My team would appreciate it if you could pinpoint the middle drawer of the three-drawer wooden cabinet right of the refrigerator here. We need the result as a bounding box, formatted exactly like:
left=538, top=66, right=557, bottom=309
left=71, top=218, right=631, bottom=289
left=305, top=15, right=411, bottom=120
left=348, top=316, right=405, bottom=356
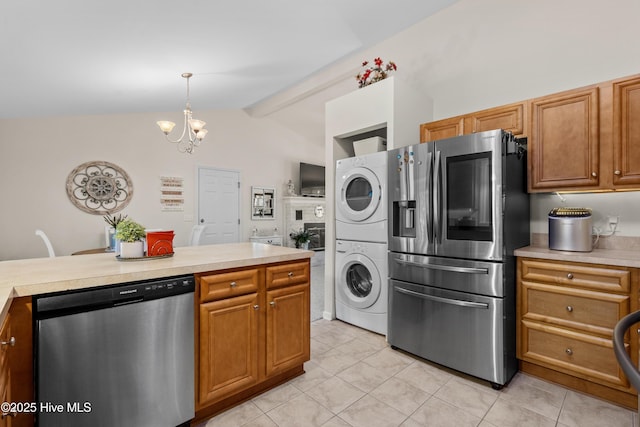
left=521, top=282, right=630, bottom=338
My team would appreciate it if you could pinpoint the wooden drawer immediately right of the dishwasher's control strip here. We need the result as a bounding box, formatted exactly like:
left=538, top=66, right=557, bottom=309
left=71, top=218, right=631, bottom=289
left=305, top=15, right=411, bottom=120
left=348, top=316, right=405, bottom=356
left=198, top=268, right=260, bottom=302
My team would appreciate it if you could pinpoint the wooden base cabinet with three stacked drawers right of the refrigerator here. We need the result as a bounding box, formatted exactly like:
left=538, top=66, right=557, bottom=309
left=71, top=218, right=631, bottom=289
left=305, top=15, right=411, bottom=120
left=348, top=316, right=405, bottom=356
left=517, top=258, right=638, bottom=407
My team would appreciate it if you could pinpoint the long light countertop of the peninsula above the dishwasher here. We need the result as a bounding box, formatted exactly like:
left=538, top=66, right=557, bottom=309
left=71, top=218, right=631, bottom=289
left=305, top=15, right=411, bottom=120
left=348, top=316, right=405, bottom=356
left=0, top=243, right=313, bottom=322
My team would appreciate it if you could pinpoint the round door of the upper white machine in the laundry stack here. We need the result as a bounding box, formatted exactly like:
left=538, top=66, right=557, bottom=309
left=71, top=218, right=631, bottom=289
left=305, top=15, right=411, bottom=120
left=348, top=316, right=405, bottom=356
left=338, top=168, right=381, bottom=222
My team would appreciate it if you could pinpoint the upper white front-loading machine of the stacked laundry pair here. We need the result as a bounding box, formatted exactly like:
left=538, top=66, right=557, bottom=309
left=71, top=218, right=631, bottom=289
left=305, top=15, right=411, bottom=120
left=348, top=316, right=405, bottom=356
left=335, top=151, right=388, bottom=242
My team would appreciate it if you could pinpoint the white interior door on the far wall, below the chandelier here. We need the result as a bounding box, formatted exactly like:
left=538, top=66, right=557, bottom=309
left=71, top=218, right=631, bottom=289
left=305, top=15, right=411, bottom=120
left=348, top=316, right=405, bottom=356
left=198, top=167, right=240, bottom=245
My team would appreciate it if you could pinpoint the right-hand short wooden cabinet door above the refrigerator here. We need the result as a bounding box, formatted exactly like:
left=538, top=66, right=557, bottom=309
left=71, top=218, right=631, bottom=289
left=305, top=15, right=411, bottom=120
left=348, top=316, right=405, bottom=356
left=464, top=102, right=525, bottom=135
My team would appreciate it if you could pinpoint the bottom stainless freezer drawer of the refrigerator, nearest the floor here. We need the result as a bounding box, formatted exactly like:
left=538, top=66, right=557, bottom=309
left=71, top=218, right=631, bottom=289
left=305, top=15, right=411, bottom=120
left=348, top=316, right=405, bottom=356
left=387, top=280, right=516, bottom=386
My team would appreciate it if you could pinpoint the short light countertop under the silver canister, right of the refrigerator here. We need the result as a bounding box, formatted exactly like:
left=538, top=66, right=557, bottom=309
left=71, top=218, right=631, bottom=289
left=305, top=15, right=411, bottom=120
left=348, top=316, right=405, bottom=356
left=514, top=246, right=640, bottom=268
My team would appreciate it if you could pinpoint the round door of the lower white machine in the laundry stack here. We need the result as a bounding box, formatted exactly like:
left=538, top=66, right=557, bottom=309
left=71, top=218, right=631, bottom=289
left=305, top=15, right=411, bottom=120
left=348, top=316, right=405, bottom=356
left=339, top=254, right=382, bottom=308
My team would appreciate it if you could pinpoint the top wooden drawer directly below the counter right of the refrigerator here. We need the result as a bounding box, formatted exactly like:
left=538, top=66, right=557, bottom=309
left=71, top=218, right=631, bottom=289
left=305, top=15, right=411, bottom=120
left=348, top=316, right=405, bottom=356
left=522, top=259, right=631, bottom=293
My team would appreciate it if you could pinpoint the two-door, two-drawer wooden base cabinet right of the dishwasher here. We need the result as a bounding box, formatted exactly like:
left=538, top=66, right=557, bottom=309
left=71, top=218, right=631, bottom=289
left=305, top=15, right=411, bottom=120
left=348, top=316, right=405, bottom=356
left=196, top=260, right=310, bottom=420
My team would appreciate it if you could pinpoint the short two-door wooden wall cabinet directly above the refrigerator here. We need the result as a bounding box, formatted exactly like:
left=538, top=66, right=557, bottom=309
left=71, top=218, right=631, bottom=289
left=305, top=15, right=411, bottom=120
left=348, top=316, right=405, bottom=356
left=420, top=102, right=527, bottom=142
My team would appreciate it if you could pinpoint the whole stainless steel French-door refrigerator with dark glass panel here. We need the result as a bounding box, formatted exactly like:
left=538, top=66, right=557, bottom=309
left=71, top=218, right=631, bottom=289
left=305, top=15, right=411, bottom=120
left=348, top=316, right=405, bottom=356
left=388, top=130, right=529, bottom=387
